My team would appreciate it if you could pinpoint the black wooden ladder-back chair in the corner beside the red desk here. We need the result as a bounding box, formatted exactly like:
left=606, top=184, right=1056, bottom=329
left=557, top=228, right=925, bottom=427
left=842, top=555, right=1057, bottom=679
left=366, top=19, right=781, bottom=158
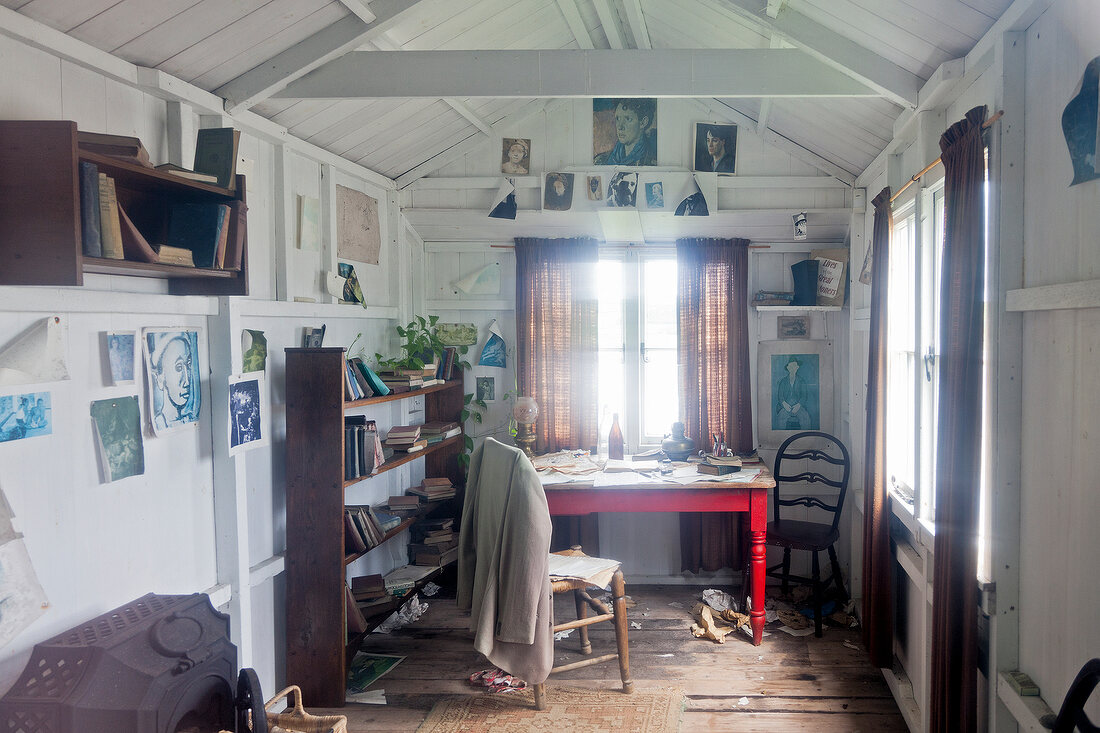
left=746, top=430, right=851, bottom=636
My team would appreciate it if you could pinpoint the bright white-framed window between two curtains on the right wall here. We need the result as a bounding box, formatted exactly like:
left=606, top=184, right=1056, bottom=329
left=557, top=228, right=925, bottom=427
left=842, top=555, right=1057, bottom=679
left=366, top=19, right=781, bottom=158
left=887, top=179, right=944, bottom=522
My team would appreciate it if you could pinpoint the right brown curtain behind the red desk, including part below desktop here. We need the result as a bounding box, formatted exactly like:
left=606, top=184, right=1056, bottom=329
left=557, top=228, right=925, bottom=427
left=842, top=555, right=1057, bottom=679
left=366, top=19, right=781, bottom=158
left=677, top=239, right=752, bottom=572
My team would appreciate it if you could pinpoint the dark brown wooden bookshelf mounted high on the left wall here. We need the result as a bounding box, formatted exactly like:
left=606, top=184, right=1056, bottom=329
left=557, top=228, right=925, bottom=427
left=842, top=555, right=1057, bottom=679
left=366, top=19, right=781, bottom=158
left=0, top=120, right=249, bottom=295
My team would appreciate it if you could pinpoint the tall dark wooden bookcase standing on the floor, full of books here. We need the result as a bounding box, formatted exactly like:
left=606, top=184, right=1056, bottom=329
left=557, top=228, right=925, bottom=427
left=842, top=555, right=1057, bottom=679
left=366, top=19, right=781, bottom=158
left=286, top=348, right=464, bottom=707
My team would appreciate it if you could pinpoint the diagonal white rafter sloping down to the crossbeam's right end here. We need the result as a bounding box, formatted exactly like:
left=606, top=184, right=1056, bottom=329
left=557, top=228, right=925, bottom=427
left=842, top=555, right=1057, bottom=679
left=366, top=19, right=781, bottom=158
left=726, top=0, right=924, bottom=107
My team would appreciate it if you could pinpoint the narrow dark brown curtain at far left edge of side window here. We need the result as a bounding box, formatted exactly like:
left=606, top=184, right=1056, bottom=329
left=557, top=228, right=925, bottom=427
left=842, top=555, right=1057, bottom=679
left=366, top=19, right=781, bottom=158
left=862, top=186, right=893, bottom=667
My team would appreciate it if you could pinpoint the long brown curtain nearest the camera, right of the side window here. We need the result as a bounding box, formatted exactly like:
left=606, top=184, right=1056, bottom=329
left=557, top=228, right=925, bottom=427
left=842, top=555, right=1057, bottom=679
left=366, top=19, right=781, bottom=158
left=931, top=102, right=986, bottom=733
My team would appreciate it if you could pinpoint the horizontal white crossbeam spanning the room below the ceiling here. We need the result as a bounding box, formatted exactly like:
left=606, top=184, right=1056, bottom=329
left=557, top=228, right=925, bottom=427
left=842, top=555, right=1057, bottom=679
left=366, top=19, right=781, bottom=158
left=274, top=48, right=878, bottom=99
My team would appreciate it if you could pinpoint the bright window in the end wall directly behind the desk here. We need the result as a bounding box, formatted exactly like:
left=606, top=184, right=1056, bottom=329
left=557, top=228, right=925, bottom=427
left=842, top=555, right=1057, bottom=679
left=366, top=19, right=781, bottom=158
left=597, top=248, right=680, bottom=450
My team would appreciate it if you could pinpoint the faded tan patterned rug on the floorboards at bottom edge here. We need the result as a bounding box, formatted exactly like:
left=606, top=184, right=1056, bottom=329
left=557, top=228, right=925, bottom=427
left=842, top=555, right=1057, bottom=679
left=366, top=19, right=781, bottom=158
left=417, top=685, right=684, bottom=733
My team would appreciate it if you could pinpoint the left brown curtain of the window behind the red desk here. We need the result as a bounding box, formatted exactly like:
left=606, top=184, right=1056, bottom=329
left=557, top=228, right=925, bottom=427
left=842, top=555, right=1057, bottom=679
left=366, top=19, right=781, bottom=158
left=516, top=239, right=600, bottom=452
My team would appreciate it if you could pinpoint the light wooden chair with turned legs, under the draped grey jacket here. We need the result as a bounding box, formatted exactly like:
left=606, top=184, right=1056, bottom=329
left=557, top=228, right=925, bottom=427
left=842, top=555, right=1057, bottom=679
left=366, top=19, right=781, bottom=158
left=535, top=545, right=634, bottom=710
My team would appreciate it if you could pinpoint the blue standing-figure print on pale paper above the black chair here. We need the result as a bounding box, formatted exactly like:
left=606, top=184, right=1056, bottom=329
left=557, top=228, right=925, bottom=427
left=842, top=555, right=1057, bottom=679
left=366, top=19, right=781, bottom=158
left=757, top=340, right=833, bottom=448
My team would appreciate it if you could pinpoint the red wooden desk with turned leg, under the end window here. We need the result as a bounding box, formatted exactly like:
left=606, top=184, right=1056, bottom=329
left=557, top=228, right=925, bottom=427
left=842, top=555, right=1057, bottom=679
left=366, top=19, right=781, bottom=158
left=543, top=468, right=776, bottom=646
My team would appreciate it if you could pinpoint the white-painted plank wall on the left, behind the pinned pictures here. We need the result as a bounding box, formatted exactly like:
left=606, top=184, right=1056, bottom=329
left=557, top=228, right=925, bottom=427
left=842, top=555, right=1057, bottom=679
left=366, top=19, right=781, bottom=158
left=0, top=22, right=404, bottom=690
